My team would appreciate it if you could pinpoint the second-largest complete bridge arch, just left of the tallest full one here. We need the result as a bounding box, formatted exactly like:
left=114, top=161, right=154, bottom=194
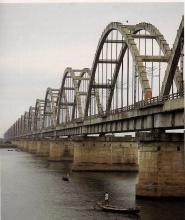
left=57, top=67, right=90, bottom=124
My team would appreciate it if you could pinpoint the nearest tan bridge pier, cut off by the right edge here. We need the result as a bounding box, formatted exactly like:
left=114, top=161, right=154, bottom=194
left=136, top=134, right=185, bottom=197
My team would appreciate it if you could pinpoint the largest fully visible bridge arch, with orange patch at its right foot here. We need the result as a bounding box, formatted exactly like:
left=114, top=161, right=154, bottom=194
left=85, top=18, right=183, bottom=116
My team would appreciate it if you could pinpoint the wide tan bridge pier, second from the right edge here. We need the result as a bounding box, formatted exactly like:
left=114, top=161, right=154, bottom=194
left=73, top=137, right=138, bottom=171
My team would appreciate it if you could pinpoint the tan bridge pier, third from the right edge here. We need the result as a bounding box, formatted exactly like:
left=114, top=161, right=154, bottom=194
left=49, top=139, right=74, bottom=161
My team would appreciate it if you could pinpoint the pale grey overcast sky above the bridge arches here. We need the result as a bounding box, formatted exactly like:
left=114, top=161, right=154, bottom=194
left=0, top=3, right=184, bottom=137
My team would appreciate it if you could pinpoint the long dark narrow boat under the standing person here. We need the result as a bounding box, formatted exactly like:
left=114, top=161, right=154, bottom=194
left=97, top=202, right=140, bottom=214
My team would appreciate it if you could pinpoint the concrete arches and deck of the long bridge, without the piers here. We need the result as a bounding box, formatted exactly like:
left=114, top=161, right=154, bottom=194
left=5, top=17, right=184, bottom=139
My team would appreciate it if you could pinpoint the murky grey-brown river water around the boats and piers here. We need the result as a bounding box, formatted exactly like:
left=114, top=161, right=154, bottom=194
left=0, top=149, right=185, bottom=220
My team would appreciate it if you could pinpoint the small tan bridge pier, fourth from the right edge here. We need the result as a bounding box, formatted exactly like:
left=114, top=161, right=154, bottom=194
left=36, top=140, right=50, bottom=157
